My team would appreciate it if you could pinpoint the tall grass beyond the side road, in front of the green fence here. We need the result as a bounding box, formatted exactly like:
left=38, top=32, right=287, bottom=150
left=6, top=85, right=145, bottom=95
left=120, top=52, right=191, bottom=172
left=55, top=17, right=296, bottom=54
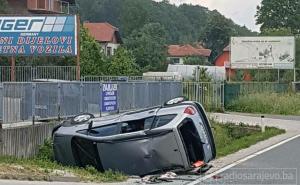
left=226, top=93, right=300, bottom=116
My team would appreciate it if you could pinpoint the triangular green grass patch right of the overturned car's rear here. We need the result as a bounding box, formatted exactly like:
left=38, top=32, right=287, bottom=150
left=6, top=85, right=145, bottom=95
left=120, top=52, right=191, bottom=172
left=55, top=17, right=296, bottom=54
left=211, top=120, right=285, bottom=157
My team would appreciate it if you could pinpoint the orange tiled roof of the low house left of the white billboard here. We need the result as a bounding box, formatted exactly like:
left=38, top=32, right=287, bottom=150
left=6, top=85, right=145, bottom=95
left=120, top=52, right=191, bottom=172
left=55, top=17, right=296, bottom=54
left=168, top=44, right=211, bottom=57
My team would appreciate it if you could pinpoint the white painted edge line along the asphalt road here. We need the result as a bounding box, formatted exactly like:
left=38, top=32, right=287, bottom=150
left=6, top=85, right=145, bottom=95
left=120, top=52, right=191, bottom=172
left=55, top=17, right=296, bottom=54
left=187, top=134, right=300, bottom=185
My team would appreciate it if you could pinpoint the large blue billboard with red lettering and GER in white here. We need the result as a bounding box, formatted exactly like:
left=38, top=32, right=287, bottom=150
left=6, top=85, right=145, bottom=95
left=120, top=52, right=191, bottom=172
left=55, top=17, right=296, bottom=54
left=0, top=15, right=77, bottom=56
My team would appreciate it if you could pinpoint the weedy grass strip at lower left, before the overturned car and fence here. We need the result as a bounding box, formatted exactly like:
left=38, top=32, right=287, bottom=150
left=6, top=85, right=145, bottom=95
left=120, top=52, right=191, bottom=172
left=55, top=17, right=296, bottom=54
left=0, top=140, right=128, bottom=182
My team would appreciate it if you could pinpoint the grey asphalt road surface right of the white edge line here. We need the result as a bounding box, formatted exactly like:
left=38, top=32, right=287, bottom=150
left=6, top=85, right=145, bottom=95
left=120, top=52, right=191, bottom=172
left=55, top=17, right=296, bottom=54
left=199, top=138, right=300, bottom=185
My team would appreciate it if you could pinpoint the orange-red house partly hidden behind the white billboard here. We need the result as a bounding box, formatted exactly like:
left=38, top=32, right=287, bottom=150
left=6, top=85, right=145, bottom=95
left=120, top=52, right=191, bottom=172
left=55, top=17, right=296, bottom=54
left=214, top=45, right=252, bottom=81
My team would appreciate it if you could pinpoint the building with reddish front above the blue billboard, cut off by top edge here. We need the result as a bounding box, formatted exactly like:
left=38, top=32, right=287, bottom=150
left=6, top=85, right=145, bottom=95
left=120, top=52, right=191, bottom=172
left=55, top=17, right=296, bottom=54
left=7, top=0, right=75, bottom=15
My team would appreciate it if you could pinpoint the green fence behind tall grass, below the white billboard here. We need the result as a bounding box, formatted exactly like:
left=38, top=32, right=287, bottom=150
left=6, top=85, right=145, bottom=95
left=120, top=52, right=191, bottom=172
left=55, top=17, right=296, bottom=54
left=224, top=82, right=291, bottom=107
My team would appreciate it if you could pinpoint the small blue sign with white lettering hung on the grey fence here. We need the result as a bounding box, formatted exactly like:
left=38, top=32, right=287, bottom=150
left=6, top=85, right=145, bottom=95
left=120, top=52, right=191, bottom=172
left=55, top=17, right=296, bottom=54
left=101, top=83, right=118, bottom=112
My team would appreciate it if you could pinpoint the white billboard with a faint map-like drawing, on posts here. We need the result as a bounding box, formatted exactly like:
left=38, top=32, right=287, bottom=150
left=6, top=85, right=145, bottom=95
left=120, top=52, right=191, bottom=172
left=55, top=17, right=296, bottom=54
left=231, top=37, right=295, bottom=69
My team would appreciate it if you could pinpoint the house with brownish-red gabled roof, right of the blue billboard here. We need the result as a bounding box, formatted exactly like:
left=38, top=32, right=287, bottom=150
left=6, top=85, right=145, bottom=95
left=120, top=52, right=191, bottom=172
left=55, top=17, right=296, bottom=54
left=83, top=22, right=122, bottom=56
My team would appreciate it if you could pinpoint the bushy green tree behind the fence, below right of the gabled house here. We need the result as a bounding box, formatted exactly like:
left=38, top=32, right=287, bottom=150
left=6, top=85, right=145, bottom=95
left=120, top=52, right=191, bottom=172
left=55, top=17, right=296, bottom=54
left=106, top=47, right=140, bottom=76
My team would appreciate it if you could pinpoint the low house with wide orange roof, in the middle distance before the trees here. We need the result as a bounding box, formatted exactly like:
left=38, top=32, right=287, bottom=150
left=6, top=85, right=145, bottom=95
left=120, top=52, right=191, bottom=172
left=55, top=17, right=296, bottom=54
left=168, top=44, right=211, bottom=64
